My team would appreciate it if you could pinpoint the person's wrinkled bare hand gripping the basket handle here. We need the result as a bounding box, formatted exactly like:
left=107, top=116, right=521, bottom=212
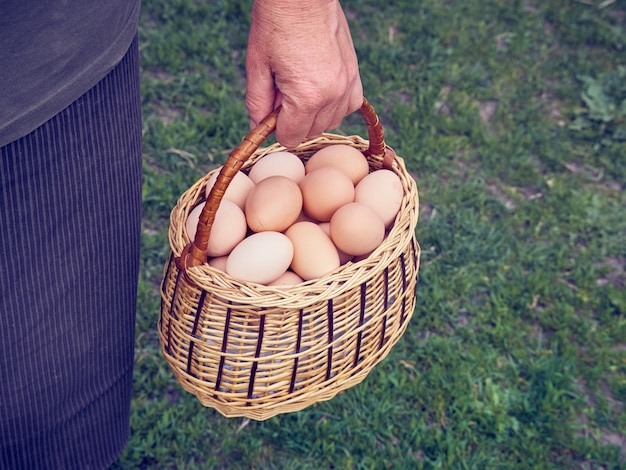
left=246, top=0, right=363, bottom=148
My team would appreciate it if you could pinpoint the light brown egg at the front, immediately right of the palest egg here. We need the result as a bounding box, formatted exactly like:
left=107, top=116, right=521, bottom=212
left=285, top=222, right=339, bottom=280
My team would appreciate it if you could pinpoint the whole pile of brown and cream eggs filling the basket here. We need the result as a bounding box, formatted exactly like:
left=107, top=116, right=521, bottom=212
left=185, top=144, right=404, bottom=286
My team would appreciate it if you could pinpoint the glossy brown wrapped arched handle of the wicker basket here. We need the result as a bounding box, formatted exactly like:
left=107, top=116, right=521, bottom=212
left=176, top=98, right=396, bottom=272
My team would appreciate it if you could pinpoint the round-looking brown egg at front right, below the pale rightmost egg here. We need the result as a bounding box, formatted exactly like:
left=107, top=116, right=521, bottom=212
left=330, top=202, right=385, bottom=256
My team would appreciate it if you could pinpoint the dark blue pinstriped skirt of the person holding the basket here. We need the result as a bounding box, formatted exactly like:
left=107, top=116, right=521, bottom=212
left=0, top=35, right=141, bottom=470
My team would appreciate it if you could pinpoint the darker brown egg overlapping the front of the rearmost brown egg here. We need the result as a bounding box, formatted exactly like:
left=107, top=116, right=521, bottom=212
left=300, top=166, right=354, bottom=222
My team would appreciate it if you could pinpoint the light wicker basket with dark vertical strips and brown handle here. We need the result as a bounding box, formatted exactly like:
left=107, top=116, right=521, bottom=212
left=158, top=100, right=420, bottom=420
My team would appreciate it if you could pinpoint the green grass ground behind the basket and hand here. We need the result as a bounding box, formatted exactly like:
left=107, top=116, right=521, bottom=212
left=113, top=0, right=626, bottom=469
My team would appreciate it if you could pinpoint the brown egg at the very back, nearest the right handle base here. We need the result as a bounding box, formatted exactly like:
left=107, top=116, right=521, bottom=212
left=305, top=144, right=369, bottom=184
